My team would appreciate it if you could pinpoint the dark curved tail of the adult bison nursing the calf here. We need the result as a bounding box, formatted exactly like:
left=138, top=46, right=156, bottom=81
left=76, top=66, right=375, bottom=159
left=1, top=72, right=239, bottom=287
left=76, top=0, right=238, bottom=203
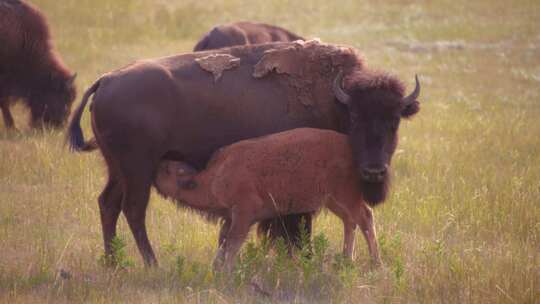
left=66, top=80, right=99, bottom=152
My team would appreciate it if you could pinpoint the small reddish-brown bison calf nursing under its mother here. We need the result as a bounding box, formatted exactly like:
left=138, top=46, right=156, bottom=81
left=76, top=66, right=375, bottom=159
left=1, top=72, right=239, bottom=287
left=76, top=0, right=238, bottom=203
left=155, top=128, right=379, bottom=270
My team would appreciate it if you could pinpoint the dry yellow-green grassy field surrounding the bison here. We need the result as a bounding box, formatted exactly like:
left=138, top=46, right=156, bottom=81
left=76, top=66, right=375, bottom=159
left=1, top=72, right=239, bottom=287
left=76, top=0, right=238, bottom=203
left=0, top=0, right=540, bottom=304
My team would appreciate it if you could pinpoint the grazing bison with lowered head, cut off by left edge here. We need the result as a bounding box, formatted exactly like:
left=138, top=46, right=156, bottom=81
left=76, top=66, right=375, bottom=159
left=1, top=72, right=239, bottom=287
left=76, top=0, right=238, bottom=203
left=0, top=0, right=75, bottom=128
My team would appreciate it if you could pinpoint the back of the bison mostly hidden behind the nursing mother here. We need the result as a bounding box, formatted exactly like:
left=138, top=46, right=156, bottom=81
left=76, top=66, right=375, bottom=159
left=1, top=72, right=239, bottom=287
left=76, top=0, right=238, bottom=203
left=193, top=21, right=304, bottom=52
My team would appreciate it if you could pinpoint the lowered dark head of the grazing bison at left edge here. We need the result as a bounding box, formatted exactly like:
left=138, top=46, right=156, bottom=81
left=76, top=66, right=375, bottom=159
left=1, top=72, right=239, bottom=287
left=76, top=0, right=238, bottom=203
left=32, top=74, right=77, bottom=127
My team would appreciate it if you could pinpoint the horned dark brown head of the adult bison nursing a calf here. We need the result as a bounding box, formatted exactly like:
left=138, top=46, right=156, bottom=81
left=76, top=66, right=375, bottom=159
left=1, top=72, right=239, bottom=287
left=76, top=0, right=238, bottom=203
left=333, top=71, right=420, bottom=205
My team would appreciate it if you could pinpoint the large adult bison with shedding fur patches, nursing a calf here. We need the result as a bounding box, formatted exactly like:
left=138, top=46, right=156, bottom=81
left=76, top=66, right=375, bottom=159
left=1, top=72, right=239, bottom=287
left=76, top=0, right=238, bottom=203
left=68, top=41, right=420, bottom=264
